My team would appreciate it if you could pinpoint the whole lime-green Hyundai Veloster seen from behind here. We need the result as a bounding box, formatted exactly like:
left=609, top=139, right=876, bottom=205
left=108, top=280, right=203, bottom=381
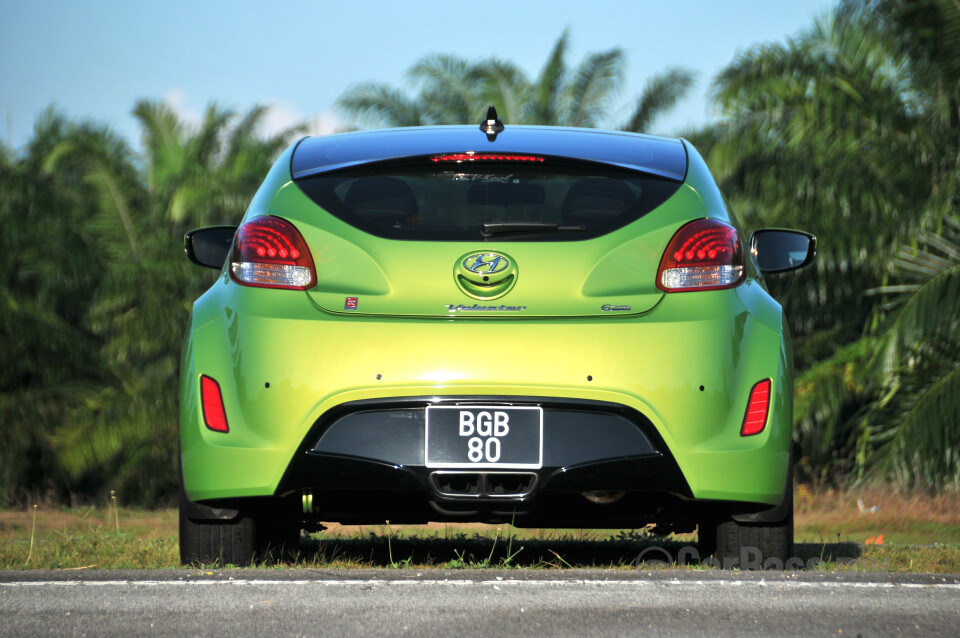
left=180, top=108, right=816, bottom=567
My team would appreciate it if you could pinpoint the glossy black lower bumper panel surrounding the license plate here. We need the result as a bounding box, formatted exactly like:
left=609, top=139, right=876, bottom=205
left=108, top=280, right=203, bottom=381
left=276, top=396, right=692, bottom=520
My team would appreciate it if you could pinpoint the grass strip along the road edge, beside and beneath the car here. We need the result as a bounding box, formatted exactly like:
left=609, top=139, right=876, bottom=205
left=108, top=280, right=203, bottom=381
left=0, top=486, right=960, bottom=573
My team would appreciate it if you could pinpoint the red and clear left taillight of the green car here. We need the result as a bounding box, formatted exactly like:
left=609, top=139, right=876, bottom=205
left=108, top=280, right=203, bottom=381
left=230, top=215, right=317, bottom=290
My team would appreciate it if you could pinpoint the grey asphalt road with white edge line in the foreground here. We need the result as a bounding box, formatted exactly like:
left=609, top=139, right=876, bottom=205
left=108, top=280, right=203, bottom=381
left=0, top=569, right=960, bottom=638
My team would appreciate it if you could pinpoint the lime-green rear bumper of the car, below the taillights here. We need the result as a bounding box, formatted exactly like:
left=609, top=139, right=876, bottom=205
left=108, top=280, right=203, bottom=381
left=181, top=283, right=792, bottom=520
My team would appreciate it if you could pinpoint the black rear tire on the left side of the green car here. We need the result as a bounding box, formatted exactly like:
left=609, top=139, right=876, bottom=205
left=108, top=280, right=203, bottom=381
left=180, top=502, right=257, bottom=565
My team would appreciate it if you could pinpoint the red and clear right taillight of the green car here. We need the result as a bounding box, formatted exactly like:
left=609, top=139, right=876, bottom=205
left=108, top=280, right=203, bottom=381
left=657, top=219, right=747, bottom=292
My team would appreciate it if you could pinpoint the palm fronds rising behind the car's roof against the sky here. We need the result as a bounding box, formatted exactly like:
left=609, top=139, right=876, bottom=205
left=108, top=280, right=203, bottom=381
left=337, top=31, right=694, bottom=132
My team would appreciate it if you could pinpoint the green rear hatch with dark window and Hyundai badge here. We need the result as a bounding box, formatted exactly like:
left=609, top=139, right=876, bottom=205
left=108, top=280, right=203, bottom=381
left=272, top=131, right=703, bottom=317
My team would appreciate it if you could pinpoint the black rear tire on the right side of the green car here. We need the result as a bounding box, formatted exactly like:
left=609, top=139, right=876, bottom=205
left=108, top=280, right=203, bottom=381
left=698, top=503, right=793, bottom=569
